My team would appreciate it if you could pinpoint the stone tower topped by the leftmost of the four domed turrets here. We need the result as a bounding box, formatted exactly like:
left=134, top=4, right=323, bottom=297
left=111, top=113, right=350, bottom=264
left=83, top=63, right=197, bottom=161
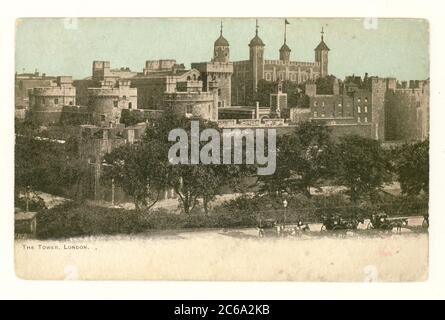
left=192, top=23, right=233, bottom=108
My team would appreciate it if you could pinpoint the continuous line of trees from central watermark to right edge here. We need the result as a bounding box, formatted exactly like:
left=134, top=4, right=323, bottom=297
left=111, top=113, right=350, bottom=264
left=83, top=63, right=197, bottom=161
left=101, top=114, right=429, bottom=213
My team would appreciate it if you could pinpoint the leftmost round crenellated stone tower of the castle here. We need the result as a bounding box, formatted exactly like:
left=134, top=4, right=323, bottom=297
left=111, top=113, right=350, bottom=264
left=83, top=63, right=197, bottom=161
left=29, top=77, right=76, bottom=124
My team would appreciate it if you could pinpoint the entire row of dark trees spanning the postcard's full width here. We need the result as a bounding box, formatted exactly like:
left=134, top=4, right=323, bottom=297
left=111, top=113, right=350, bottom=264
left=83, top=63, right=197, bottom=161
left=15, top=114, right=429, bottom=213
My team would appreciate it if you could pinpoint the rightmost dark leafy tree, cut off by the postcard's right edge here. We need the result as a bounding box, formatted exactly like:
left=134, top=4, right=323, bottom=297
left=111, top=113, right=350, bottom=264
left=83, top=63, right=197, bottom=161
left=394, top=140, right=429, bottom=196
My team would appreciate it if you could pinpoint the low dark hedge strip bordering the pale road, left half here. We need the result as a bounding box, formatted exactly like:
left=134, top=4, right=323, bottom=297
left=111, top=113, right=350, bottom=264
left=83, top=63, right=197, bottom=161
left=37, top=202, right=256, bottom=239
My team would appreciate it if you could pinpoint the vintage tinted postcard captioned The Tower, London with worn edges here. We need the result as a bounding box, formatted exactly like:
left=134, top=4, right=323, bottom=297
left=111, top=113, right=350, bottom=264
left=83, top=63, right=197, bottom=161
left=14, top=17, right=430, bottom=282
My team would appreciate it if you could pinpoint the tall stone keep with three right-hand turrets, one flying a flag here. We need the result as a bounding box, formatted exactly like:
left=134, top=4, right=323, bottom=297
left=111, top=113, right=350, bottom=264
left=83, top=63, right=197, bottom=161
left=232, top=23, right=330, bottom=105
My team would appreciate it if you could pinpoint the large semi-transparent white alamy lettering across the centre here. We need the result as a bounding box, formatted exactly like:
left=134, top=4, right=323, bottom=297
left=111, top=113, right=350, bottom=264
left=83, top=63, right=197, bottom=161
left=168, top=121, right=277, bottom=175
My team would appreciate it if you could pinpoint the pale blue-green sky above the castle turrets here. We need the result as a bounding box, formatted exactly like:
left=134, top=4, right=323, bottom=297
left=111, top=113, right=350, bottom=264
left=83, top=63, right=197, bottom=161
left=16, top=18, right=429, bottom=80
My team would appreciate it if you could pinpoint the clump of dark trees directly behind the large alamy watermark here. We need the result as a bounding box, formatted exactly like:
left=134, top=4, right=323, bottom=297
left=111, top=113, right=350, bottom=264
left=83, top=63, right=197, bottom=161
left=104, top=113, right=253, bottom=213
